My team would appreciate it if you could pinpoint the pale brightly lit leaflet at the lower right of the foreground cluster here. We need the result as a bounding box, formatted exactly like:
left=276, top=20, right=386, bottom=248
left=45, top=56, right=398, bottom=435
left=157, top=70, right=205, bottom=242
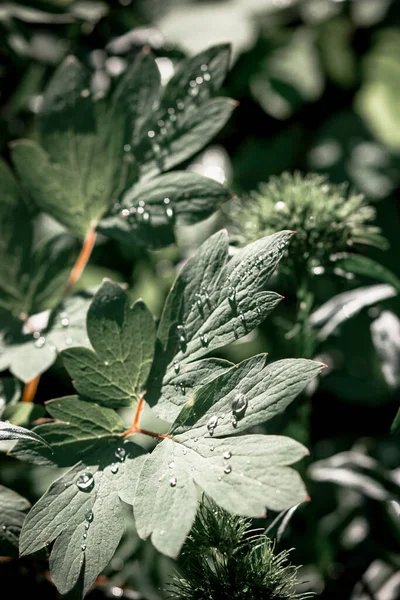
left=134, top=434, right=307, bottom=557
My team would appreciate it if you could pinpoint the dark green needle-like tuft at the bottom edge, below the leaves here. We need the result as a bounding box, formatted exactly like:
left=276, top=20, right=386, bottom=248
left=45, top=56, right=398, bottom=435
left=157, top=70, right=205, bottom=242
left=173, top=499, right=311, bottom=600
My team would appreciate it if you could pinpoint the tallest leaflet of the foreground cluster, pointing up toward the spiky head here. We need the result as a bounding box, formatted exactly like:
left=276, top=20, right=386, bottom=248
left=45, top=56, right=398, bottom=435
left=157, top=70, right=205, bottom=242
left=146, top=231, right=292, bottom=420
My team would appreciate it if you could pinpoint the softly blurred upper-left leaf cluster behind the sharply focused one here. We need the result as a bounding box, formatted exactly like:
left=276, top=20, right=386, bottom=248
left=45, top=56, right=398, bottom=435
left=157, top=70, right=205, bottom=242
left=0, top=45, right=234, bottom=382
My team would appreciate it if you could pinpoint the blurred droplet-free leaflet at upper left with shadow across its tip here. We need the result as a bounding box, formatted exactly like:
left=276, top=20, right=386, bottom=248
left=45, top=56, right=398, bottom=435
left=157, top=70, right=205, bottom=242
left=12, top=57, right=126, bottom=238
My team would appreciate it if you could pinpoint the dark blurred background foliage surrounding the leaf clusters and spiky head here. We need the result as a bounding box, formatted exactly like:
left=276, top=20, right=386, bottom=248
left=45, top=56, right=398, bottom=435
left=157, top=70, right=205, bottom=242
left=0, top=0, right=400, bottom=600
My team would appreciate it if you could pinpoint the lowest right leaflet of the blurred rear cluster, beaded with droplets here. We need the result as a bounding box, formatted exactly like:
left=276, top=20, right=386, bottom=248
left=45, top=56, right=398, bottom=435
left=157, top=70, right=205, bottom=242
left=99, top=171, right=231, bottom=246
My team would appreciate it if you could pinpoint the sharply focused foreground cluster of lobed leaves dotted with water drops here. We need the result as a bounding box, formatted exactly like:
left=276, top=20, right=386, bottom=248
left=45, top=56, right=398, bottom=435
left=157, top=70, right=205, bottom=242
left=1, top=232, right=323, bottom=593
